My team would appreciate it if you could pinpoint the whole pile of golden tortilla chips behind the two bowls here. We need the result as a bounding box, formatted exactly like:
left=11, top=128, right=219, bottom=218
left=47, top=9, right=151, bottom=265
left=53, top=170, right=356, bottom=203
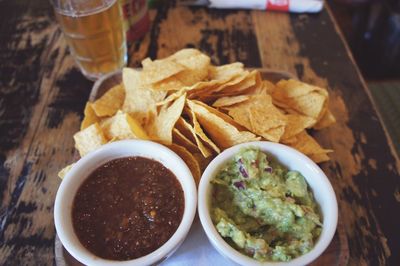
left=62, top=49, right=335, bottom=182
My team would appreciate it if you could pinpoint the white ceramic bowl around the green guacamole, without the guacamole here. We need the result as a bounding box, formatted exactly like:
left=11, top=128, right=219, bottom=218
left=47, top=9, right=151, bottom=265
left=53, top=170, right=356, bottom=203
left=198, top=141, right=338, bottom=266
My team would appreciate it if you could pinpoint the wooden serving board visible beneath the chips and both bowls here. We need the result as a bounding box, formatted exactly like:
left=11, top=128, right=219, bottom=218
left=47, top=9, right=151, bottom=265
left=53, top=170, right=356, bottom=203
left=54, top=69, right=349, bottom=266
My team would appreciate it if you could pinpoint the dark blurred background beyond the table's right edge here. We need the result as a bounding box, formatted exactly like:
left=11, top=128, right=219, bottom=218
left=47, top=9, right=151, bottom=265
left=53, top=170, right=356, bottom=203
left=327, top=0, right=400, bottom=156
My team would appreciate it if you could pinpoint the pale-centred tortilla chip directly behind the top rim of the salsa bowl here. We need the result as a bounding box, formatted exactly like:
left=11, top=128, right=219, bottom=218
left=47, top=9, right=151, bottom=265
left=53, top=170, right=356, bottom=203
left=100, top=111, right=148, bottom=140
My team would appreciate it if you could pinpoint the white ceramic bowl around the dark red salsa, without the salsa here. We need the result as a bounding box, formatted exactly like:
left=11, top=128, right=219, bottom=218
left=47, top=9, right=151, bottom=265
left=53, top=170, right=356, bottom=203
left=54, top=140, right=197, bottom=265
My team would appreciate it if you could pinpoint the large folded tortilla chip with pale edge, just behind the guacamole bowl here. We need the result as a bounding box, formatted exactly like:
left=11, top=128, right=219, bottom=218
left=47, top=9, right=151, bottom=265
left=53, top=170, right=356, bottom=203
left=187, top=100, right=260, bottom=149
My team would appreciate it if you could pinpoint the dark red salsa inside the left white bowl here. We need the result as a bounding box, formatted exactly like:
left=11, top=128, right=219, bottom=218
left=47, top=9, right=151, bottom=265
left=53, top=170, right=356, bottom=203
left=72, top=157, right=184, bottom=261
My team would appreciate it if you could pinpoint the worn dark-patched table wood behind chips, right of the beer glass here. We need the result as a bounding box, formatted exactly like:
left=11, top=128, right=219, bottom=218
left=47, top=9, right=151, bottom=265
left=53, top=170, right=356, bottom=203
left=129, top=1, right=261, bottom=67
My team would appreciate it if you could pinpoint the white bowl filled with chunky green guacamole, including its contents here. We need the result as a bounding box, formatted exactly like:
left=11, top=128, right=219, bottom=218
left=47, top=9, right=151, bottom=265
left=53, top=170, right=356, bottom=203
left=198, top=141, right=338, bottom=265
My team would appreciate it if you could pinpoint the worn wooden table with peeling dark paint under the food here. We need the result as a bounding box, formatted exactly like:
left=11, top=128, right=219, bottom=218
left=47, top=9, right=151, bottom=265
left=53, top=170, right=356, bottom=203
left=0, top=0, right=400, bottom=265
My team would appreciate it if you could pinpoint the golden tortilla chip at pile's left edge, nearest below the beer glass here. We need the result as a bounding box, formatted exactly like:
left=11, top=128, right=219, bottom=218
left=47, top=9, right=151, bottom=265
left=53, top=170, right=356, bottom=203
left=92, top=84, right=125, bottom=117
